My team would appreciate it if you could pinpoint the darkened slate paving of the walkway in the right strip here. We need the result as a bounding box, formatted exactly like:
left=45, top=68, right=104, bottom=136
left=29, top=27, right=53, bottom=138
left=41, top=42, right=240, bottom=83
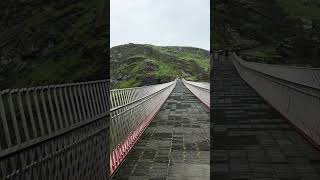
left=210, top=55, right=320, bottom=180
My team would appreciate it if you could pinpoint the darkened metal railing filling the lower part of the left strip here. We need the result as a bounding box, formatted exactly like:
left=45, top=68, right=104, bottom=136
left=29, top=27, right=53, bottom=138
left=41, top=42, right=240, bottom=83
left=0, top=80, right=110, bottom=179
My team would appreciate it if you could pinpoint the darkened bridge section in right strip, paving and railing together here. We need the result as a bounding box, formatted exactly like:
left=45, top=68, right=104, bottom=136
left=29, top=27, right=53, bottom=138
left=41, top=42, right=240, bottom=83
left=211, top=54, right=320, bottom=180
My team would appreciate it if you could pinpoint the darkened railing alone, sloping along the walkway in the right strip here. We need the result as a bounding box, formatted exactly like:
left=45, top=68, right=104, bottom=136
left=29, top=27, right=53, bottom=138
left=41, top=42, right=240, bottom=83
left=232, top=54, right=320, bottom=146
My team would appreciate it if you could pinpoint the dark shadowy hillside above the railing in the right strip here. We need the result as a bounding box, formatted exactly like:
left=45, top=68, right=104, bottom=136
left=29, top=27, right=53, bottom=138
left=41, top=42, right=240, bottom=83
left=211, top=0, right=320, bottom=67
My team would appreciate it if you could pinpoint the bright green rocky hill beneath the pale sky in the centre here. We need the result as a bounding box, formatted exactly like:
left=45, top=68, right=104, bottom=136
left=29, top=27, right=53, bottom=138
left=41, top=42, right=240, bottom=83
left=110, top=43, right=209, bottom=88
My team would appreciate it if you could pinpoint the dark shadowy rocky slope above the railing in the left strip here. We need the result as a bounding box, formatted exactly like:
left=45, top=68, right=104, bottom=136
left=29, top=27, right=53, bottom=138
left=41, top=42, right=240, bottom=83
left=0, top=0, right=109, bottom=90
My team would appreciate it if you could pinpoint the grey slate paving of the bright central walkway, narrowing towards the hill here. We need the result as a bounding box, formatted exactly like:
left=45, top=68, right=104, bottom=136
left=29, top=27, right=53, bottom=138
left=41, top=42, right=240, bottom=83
left=112, top=81, right=210, bottom=180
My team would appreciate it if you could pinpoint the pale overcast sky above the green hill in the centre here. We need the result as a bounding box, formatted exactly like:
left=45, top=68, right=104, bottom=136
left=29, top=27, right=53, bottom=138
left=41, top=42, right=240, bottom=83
left=110, top=0, right=210, bottom=50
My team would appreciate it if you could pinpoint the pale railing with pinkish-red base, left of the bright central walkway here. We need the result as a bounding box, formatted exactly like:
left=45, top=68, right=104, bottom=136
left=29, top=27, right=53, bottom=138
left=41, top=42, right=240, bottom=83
left=110, top=80, right=176, bottom=175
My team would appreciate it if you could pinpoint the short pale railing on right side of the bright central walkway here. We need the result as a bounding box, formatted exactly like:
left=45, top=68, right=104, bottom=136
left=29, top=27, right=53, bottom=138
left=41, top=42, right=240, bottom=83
left=182, top=79, right=210, bottom=108
